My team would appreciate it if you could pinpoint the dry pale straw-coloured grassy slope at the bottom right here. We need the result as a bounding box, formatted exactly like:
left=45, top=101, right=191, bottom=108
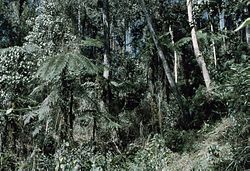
left=167, top=118, right=234, bottom=171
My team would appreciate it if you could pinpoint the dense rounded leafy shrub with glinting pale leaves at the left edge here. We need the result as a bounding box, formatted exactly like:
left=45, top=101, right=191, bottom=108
left=0, top=45, right=38, bottom=106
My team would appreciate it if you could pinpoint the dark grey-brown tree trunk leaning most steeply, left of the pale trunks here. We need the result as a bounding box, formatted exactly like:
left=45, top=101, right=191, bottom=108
left=140, top=0, right=187, bottom=115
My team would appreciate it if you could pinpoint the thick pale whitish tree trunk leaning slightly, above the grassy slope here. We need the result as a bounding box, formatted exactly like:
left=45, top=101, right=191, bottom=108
left=187, top=0, right=211, bottom=91
